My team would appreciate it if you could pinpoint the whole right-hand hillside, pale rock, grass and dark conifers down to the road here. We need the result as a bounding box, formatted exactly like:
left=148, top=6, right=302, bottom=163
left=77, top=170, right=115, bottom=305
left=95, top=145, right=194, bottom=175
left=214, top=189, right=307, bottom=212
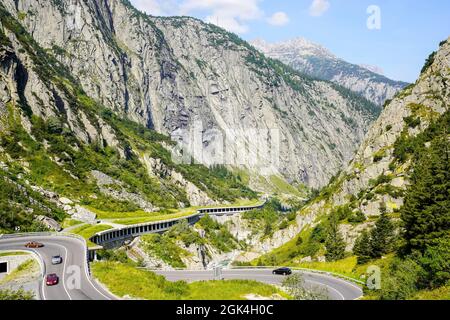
left=252, top=41, right=450, bottom=300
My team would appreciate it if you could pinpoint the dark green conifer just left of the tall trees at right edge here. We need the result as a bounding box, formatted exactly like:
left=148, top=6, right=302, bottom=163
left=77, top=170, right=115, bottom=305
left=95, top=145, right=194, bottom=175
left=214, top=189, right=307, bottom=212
left=370, top=212, right=395, bottom=258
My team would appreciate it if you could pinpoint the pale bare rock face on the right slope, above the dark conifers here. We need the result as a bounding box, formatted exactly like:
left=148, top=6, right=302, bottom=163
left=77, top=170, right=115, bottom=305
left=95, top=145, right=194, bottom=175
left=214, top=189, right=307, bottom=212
left=266, top=39, right=450, bottom=251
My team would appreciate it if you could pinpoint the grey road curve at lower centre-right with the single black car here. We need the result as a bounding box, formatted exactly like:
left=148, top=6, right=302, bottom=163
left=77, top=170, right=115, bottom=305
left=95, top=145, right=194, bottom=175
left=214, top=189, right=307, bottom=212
left=155, top=269, right=363, bottom=300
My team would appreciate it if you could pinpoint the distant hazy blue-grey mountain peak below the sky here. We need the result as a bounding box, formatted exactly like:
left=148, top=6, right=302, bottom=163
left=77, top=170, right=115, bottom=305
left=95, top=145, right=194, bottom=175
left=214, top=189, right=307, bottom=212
left=252, top=38, right=408, bottom=105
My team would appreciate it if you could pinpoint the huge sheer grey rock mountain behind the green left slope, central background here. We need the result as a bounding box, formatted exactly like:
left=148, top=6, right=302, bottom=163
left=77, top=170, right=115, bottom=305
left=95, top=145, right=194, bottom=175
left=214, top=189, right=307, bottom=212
left=1, top=0, right=380, bottom=187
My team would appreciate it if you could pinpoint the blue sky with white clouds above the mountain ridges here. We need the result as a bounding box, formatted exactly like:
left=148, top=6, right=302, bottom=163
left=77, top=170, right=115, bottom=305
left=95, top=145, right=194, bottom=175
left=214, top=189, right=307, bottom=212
left=131, top=0, right=450, bottom=82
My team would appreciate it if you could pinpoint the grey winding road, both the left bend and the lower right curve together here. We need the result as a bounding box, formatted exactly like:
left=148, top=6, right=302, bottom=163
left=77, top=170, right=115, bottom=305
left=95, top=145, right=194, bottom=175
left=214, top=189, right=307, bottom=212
left=0, top=235, right=362, bottom=300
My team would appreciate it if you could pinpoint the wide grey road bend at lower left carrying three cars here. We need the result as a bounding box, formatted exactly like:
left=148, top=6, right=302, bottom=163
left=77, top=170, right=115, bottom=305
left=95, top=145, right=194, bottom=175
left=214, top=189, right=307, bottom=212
left=0, top=236, right=114, bottom=300
